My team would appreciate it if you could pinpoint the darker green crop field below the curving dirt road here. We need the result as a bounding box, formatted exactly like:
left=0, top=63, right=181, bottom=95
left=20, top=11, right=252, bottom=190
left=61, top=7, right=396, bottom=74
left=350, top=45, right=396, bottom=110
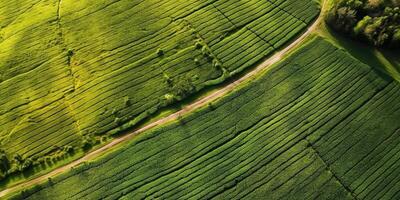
left=9, top=37, right=400, bottom=199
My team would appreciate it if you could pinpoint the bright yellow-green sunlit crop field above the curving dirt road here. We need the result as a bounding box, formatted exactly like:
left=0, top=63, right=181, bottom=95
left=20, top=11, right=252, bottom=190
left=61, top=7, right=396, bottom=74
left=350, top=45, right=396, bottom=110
left=0, top=0, right=319, bottom=172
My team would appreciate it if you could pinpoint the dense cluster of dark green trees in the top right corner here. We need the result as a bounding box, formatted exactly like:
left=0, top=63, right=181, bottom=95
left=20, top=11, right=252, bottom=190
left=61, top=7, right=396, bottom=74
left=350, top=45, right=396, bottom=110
left=326, top=0, right=400, bottom=48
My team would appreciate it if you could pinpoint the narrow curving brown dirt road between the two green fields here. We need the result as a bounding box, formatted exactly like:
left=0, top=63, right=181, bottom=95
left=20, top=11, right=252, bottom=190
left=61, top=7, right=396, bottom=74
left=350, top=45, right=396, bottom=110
left=0, top=0, right=328, bottom=198
